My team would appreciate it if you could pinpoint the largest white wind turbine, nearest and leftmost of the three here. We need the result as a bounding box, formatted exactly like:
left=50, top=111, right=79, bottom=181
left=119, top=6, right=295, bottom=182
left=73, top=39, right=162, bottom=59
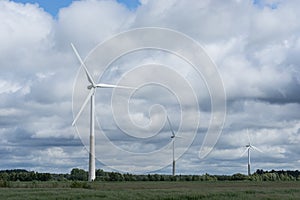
left=71, top=43, right=133, bottom=181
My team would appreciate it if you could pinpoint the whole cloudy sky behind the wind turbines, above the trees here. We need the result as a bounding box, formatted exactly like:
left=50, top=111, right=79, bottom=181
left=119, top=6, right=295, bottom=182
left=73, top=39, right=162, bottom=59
left=0, top=0, right=300, bottom=174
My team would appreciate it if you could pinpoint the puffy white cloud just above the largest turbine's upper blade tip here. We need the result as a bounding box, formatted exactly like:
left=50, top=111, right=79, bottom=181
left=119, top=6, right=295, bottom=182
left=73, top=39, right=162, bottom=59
left=55, top=0, right=133, bottom=52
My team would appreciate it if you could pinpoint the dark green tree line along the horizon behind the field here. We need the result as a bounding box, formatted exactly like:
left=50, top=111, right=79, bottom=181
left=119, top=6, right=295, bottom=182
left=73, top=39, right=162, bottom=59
left=0, top=168, right=300, bottom=181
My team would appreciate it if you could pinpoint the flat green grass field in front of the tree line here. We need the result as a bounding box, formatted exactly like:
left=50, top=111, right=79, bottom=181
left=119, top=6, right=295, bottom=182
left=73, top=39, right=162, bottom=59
left=0, top=181, right=300, bottom=200
